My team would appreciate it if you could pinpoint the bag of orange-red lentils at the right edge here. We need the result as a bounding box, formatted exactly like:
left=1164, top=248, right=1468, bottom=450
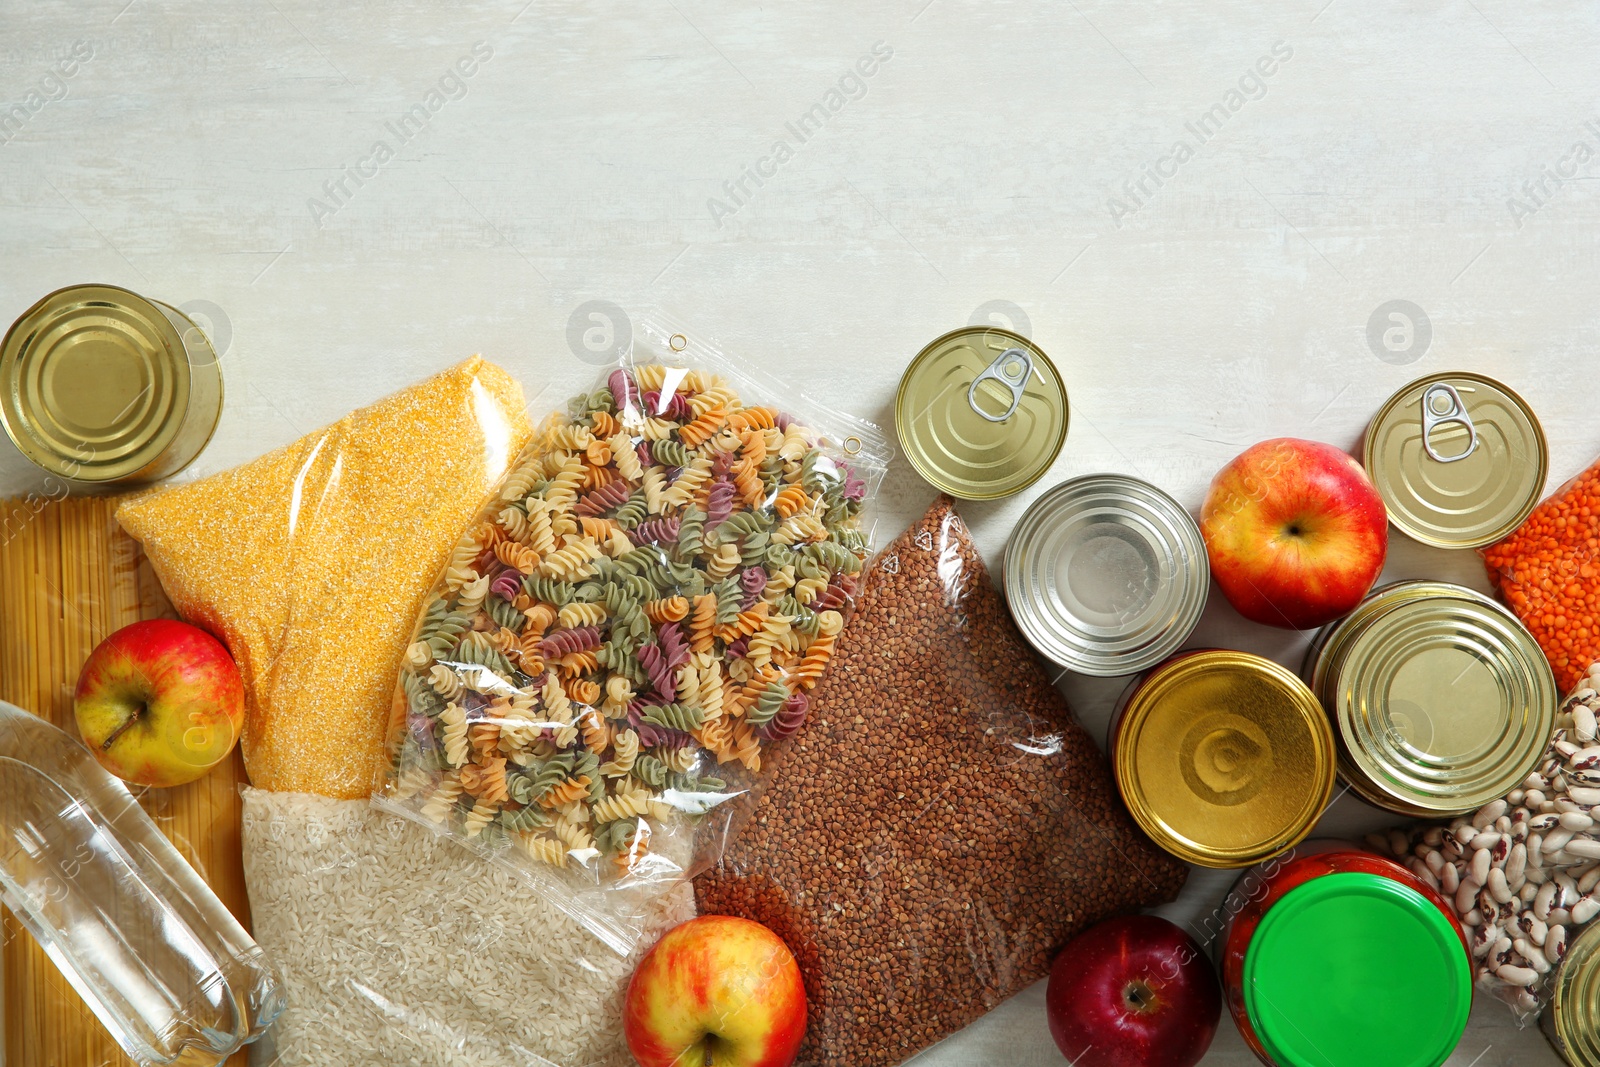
left=1480, top=462, right=1600, bottom=689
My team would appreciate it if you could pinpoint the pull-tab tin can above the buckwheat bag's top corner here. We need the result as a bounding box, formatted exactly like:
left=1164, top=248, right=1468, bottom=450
left=894, top=326, right=1067, bottom=501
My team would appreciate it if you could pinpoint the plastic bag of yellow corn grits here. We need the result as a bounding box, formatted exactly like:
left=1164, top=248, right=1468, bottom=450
left=117, top=357, right=531, bottom=800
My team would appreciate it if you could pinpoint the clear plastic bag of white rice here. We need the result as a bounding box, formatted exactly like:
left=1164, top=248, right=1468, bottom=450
left=243, top=789, right=694, bottom=1067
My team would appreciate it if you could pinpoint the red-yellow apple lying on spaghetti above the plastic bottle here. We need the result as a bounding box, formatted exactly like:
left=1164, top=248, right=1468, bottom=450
left=72, top=619, right=245, bottom=785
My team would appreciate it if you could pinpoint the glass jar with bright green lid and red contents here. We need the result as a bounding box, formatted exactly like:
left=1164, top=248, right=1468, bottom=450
left=1221, top=845, right=1472, bottom=1067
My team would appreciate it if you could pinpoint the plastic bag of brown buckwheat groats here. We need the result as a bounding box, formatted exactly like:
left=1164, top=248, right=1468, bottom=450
left=696, top=498, right=1186, bottom=1067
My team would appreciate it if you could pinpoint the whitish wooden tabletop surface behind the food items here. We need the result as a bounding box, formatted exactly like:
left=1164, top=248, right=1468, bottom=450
left=0, top=0, right=1600, bottom=1067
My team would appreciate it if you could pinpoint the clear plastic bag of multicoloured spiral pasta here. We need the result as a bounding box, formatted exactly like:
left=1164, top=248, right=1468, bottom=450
left=378, top=318, right=888, bottom=953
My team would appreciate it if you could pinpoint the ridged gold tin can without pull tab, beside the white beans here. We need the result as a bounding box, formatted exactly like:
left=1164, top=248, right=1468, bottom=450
left=1301, top=582, right=1558, bottom=817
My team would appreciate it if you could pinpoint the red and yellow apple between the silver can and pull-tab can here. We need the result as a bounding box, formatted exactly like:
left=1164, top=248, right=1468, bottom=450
left=1200, top=437, right=1389, bottom=630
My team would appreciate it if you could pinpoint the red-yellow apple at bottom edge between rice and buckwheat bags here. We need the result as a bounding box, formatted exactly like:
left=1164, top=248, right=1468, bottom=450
left=622, top=915, right=805, bottom=1067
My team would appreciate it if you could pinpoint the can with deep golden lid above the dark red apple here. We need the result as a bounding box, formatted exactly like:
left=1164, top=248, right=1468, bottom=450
left=1112, top=649, right=1334, bottom=867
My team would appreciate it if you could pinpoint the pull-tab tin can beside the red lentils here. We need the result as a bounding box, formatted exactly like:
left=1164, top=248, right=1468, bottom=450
left=1363, top=371, right=1549, bottom=549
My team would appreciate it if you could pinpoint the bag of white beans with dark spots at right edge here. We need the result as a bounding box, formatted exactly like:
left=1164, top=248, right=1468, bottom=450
left=1368, top=662, right=1600, bottom=1025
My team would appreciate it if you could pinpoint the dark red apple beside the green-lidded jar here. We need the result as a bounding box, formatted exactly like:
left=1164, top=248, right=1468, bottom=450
left=1045, top=915, right=1222, bottom=1067
